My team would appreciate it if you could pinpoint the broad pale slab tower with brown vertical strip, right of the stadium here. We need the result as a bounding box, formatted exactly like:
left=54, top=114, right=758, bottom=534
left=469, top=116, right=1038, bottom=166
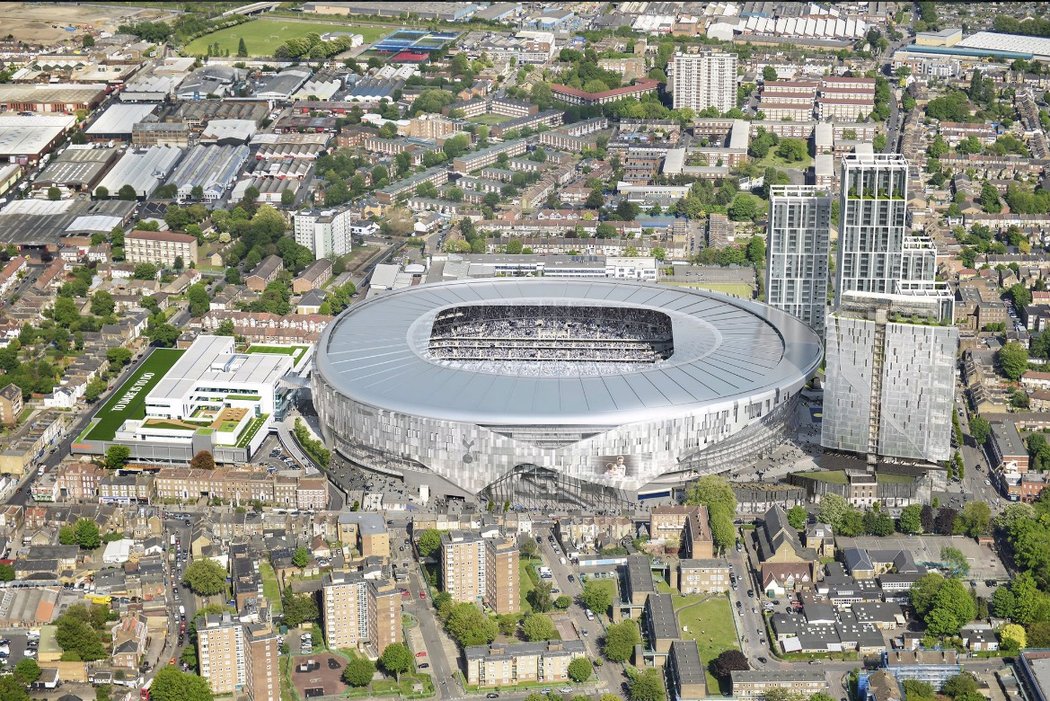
left=820, top=285, right=959, bottom=462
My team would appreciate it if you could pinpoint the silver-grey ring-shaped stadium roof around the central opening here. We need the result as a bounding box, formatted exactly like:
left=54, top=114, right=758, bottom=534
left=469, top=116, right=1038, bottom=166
left=316, top=279, right=821, bottom=426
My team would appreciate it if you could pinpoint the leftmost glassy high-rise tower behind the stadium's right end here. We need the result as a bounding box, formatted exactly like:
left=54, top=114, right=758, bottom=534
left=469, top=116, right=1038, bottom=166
left=765, top=185, right=832, bottom=334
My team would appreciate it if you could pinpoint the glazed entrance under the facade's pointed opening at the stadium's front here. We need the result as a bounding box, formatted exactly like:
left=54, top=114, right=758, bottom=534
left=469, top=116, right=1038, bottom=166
left=481, top=464, right=633, bottom=511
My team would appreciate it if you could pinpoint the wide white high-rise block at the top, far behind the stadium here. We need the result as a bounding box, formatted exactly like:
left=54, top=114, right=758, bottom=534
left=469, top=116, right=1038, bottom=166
left=668, top=50, right=736, bottom=112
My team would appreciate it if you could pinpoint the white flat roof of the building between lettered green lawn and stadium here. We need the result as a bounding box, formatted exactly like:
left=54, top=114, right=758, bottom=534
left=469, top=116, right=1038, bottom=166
left=147, top=336, right=294, bottom=401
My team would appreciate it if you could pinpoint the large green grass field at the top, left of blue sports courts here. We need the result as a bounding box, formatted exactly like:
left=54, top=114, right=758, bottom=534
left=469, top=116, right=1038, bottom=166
left=183, top=19, right=397, bottom=57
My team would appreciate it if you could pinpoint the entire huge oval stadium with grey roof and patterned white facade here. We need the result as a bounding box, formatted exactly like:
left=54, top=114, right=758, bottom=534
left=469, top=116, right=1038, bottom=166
left=313, top=279, right=821, bottom=503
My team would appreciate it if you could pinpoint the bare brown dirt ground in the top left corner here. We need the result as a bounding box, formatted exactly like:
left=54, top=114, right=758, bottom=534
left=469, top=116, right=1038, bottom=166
left=0, top=2, right=172, bottom=44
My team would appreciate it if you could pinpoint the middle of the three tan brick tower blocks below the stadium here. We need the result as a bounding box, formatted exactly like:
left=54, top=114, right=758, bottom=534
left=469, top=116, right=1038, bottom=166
left=321, top=572, right=401, bottom=657
